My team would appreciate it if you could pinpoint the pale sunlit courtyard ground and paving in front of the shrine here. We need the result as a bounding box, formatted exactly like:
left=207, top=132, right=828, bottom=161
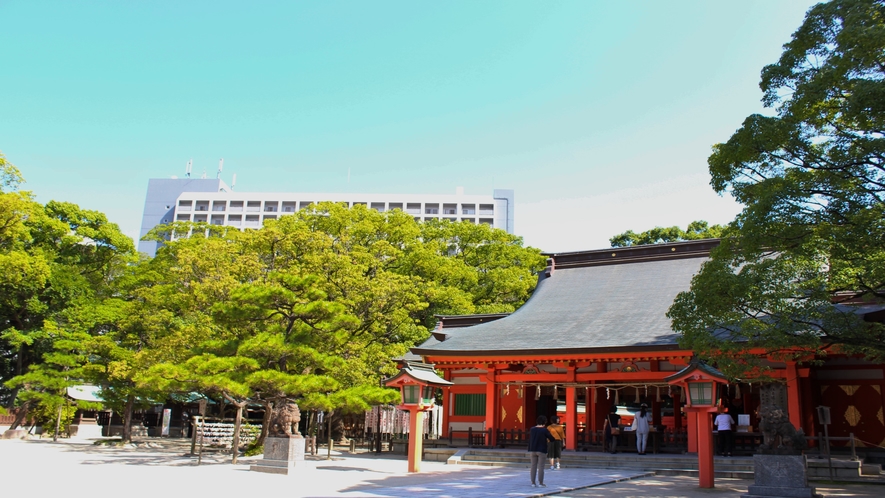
left=0, top=439, right=885, bottom=498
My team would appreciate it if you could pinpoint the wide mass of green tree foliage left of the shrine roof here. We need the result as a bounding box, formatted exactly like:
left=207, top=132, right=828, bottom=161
left=0, top=152, right=544, bottom=444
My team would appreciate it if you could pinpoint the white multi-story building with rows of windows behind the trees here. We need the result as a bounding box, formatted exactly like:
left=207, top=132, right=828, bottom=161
left=138, top=178, right=513, bottom=256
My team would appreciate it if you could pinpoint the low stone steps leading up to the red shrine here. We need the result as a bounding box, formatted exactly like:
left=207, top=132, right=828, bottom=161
left=447, top=448, right=753, bottom=479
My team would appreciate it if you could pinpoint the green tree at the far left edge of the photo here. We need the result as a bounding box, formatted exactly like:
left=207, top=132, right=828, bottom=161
left=0, top=162, right=134, bottom=417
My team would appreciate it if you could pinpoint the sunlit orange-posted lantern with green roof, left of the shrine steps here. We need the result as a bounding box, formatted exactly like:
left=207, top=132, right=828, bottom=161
left=384, top=361, right=452, bottom=472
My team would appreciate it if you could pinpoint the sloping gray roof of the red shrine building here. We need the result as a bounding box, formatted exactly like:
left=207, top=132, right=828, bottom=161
left=412, top=254, right=708, bottom=356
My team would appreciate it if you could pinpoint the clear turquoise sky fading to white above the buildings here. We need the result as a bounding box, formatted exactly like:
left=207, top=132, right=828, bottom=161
left=0, top=0, right=814, bottom=251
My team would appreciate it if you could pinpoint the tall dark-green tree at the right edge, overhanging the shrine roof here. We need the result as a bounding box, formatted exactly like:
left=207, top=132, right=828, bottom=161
left=668, top=0, right=885, bottom=375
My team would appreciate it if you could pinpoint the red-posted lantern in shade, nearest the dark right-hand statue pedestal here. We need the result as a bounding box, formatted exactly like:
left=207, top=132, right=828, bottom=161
left=664, top=357, right=728, bottom=488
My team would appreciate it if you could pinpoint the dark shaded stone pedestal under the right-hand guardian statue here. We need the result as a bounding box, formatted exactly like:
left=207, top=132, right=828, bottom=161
left=741, top=455, right=821, bottom=498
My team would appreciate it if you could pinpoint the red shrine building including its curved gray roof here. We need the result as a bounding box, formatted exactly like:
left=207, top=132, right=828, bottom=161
left=412, top=240, right=885, bottom=451
